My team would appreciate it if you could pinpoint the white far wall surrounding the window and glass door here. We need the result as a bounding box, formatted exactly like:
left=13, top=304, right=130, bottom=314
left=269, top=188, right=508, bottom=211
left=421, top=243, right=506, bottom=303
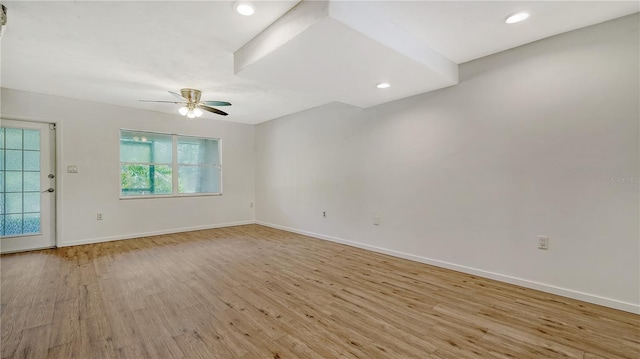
left=2, top=88, right=255, bottom=246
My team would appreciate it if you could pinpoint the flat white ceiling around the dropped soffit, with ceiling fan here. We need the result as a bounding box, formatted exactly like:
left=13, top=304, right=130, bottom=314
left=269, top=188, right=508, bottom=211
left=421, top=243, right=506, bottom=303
left=0, top=1, right=640, bottom=123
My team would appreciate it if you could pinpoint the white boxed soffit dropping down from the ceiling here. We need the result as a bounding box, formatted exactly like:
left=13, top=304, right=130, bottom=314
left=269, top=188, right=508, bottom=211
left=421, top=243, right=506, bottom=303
left=234, top=1, right=458, bottom=108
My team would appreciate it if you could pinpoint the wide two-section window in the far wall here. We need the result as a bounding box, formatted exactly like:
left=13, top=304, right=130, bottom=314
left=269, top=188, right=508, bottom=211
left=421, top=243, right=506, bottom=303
left=120, top=130, right=222, bottom=198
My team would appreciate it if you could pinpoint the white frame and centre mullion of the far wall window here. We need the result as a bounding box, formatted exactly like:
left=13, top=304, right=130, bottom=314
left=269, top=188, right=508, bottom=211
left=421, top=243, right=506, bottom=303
left=118, top=128, right=223, bottom=200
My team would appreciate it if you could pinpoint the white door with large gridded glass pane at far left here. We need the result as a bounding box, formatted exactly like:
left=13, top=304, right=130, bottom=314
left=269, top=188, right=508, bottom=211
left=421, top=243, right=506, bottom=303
left=0, top=119, right=56, bottom=253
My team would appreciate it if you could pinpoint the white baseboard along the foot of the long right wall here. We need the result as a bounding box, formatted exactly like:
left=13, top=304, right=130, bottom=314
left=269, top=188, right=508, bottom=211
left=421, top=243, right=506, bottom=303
left=255, top=221, right=640, bottom=314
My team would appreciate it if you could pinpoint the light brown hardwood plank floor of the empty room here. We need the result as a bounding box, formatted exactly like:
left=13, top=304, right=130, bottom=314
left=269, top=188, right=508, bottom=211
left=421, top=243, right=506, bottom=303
left=1, top=225, right=640, bottom=359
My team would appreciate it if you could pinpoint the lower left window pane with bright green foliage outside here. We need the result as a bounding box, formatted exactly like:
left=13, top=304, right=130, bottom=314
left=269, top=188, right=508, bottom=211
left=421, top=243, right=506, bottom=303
left=120, top=164, right=173, bottom=196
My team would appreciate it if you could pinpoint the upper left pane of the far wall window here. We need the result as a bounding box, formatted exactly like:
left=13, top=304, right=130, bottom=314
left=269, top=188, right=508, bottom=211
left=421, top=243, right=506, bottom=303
left=120, top=130, right=173, bottom=163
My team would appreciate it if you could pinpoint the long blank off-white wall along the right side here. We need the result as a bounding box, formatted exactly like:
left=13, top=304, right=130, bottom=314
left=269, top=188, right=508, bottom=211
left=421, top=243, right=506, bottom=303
left=256, top=14, right=640, bottom=312
